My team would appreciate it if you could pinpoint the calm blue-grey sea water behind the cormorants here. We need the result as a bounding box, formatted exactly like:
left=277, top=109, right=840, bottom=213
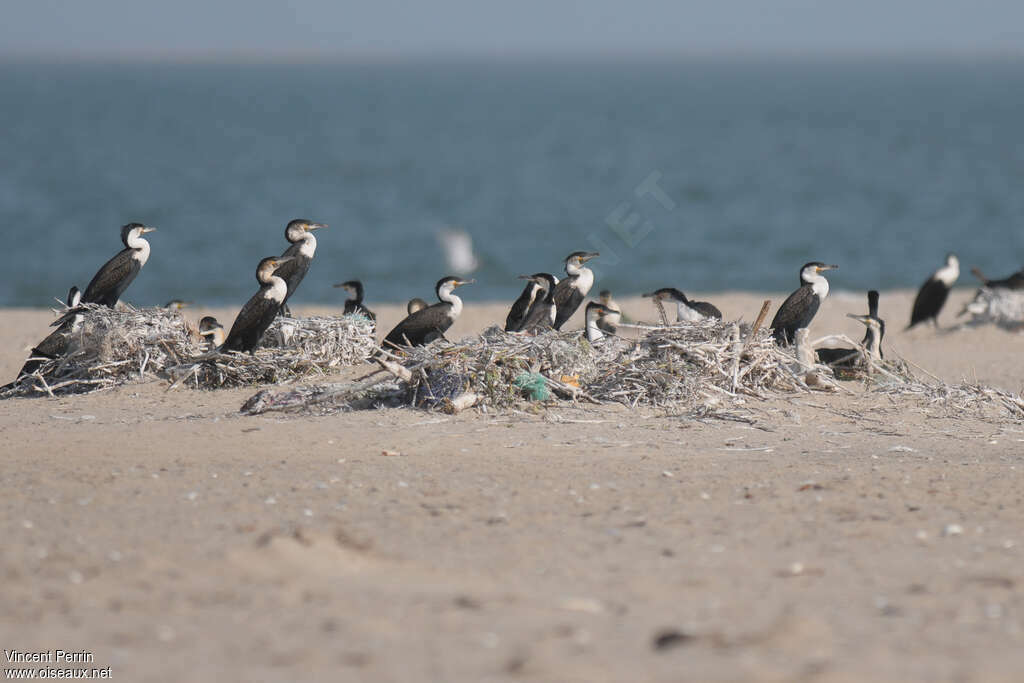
left=0, top=61, right=1024, bottom=306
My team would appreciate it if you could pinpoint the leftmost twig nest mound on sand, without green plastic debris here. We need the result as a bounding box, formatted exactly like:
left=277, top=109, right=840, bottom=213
left=0, top=304, right=376, bottom=397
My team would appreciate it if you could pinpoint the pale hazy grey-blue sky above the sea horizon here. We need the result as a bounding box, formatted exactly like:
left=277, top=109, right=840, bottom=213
left=0, top=0, right=1024, bottom=59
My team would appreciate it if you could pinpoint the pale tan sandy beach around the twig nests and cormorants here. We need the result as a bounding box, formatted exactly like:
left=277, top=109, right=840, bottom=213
left=0, top=288, right=1024, bottom=681
